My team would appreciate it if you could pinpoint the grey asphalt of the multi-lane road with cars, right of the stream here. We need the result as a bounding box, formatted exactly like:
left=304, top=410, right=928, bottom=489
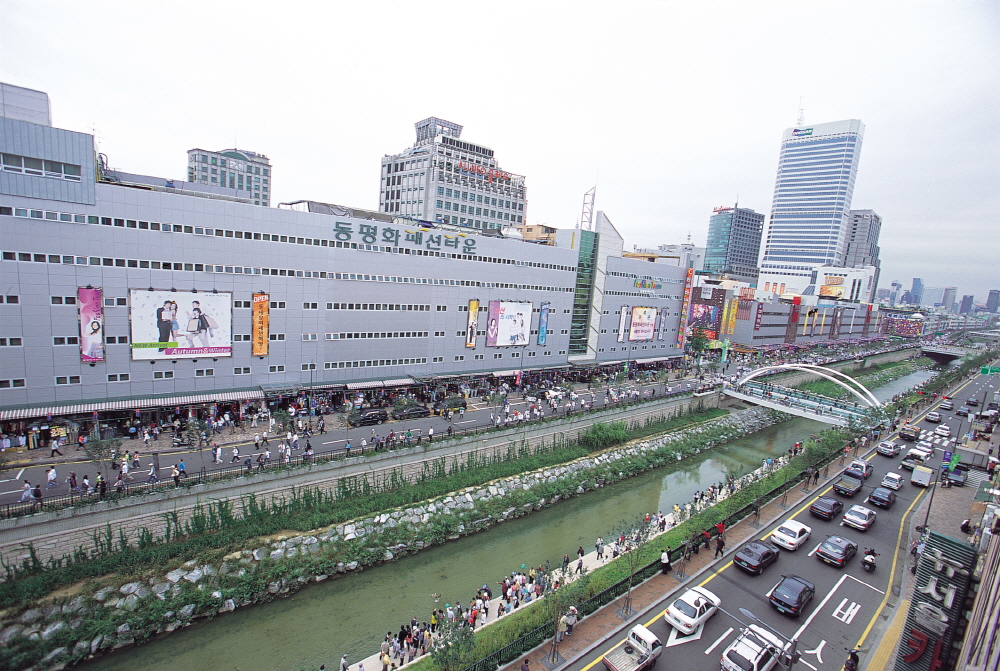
left=568, top=364, right=997, bottom=671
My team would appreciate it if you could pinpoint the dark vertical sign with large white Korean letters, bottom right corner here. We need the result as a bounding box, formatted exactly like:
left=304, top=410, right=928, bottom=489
left=895, top=531, right=976, bottom=671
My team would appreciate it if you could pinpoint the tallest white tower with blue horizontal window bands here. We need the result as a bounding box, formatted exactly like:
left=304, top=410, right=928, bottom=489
left=758, top=119, right=864, bottom=293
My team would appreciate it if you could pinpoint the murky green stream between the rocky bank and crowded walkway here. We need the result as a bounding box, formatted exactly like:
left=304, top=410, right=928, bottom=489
left=77, top=371, right=930, bottom=671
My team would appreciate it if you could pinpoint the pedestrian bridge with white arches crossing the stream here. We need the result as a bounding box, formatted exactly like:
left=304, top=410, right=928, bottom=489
left=723, top=363, right=882, bottom=426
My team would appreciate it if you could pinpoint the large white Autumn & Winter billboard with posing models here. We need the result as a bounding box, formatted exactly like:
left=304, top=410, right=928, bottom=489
left=129, top=289, right=233, bottom=361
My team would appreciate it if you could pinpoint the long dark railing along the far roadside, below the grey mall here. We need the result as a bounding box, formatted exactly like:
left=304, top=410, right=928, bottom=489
left=0, top=391, right=704, bottom=519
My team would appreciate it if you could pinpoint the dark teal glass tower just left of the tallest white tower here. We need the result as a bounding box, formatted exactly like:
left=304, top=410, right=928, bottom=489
left=704, top=206, right=764, bottom=284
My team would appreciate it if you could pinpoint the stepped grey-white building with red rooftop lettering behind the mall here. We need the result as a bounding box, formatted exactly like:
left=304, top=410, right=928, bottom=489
left=379, top=117, right=527, bottom=230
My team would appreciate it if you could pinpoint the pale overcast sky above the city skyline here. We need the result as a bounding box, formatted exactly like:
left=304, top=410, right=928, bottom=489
left=0, top=0, right=1000, bottom=302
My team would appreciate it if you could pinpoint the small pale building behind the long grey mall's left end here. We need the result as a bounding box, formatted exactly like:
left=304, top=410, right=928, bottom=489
left=188, top=149, right=272, bottom=207
